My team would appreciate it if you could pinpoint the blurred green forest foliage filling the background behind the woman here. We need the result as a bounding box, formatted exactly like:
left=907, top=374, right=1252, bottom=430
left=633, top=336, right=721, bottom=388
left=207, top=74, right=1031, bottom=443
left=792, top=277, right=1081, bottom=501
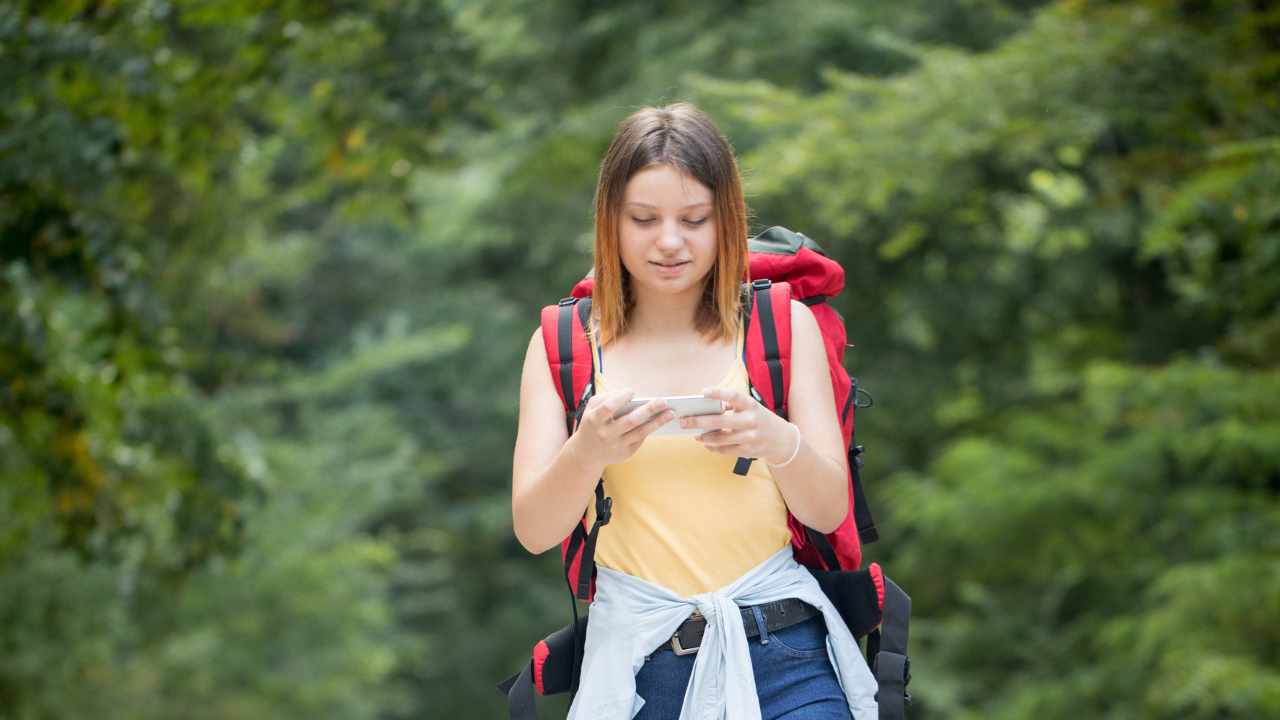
left=0, top=0, right=1280, bottom=720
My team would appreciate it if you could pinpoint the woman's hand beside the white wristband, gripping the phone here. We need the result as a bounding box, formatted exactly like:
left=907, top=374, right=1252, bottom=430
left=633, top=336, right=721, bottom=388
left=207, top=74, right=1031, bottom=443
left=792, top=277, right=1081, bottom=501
left=680, top=388, right=795, bottom=462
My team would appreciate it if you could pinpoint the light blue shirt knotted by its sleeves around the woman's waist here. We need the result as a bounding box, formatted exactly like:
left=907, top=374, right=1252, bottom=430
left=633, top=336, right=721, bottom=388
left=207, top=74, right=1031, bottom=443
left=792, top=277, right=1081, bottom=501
left=568, top=546, right=879, bottom=720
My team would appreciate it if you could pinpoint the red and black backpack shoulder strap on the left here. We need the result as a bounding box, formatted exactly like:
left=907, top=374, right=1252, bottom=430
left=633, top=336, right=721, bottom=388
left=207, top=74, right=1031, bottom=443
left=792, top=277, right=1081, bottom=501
left=541, top=297, right=594, bottom=433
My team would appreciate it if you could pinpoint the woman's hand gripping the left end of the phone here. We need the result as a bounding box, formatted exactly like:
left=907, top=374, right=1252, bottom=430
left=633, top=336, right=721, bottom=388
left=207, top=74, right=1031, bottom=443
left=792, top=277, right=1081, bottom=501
left=570, top=389, right=676, bottom=466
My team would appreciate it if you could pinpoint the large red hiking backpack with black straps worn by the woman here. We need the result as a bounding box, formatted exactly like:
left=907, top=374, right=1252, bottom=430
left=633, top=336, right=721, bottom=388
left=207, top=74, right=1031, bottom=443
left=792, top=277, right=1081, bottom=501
left=541, top=225, right=878, bottom=601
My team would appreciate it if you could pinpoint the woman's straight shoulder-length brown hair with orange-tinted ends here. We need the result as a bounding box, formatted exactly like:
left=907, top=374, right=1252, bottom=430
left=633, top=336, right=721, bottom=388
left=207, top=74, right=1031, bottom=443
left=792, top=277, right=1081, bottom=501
left=591, top=102, right=750, bottom=343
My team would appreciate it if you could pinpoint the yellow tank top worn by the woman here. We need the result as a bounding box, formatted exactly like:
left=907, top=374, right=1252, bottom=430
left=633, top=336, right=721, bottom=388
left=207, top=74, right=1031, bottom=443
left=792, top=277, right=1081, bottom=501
left=588, top=317, right=791, bottom=597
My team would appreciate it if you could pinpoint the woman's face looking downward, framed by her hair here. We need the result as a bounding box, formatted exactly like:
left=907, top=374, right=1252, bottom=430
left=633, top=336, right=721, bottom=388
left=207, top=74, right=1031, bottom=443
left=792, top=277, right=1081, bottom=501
left=618, top=165, right=717, bottom=295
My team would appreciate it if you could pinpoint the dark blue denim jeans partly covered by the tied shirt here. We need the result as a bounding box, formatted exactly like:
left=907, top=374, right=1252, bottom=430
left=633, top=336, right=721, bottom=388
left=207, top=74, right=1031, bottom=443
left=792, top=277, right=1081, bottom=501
left=634, top=607, right=850, bottom=720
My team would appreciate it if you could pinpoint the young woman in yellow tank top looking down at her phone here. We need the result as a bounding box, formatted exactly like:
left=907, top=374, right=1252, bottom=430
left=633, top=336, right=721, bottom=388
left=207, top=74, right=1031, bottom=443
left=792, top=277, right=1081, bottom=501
left=512, top=102, right=877, bottom=720
